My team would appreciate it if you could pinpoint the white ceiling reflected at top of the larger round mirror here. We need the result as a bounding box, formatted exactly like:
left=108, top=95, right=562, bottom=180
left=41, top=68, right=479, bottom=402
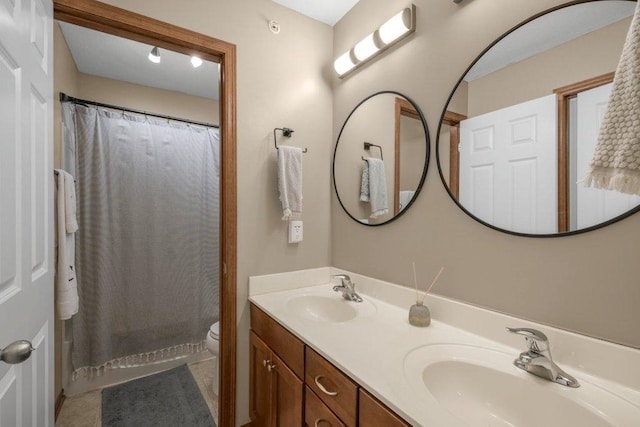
left=464, top=1, right=636, bottom=81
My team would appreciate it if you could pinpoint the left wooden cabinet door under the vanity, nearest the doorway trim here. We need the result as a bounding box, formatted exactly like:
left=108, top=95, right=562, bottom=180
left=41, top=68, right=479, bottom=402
left=249, top=331, right=272, bottom=427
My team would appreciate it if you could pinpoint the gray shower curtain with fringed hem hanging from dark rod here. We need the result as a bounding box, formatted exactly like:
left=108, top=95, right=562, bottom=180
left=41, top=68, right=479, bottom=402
left=63, top=103, right=220, bottom=378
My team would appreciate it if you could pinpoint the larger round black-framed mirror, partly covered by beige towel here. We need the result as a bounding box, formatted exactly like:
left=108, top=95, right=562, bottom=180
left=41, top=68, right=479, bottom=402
left=437, top=0, right=640, bottom=236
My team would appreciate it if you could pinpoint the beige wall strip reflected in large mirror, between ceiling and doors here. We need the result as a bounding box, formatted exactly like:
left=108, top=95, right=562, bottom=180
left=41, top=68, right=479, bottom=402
left=464, top=18, right=631, bottom=117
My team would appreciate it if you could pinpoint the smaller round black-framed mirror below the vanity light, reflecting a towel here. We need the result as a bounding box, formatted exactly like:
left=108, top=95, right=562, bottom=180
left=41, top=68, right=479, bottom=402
left=333, top=91, right=430, bottom=226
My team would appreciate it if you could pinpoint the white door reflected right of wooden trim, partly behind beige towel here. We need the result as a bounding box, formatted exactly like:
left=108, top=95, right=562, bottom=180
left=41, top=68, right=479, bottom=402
left=576, top=83, right=640, bottom=229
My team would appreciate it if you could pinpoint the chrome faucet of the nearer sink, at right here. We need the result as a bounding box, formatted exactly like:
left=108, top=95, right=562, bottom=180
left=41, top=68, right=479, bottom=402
left=507, top=328, right=580, bottom=388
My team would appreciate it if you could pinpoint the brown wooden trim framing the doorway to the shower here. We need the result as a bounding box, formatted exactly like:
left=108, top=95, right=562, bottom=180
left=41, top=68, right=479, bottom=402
left=53, top=0, right=237, bottom=426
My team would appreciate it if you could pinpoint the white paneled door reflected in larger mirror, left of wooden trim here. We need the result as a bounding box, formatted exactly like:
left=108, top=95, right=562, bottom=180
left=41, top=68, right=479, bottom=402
left=459, top=95, right=557, bottom=234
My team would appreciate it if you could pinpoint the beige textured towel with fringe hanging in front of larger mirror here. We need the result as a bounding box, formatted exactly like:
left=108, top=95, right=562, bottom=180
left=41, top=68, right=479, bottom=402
left=584, top=3, right=640, bottom=194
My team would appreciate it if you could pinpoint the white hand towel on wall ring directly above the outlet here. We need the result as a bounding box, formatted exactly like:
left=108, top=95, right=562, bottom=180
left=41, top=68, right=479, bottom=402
left=278, top=145, right=302, bottom=221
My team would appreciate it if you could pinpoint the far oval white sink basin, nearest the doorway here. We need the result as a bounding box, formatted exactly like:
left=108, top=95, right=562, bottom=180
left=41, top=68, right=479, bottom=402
left=287, top=294, right=375, bottom=323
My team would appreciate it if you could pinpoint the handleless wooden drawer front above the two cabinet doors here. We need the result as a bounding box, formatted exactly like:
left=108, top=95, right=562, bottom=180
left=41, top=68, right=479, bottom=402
left=251, top=304, right=304, bottom=379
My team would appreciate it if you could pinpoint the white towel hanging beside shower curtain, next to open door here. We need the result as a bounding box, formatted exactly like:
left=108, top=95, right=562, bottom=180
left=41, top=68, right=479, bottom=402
left=56, top=169, right=78, bottom=320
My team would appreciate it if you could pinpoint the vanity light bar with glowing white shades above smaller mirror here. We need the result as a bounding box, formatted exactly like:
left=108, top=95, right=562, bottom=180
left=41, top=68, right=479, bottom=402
left=333, top=4, right=416, bottom=78
